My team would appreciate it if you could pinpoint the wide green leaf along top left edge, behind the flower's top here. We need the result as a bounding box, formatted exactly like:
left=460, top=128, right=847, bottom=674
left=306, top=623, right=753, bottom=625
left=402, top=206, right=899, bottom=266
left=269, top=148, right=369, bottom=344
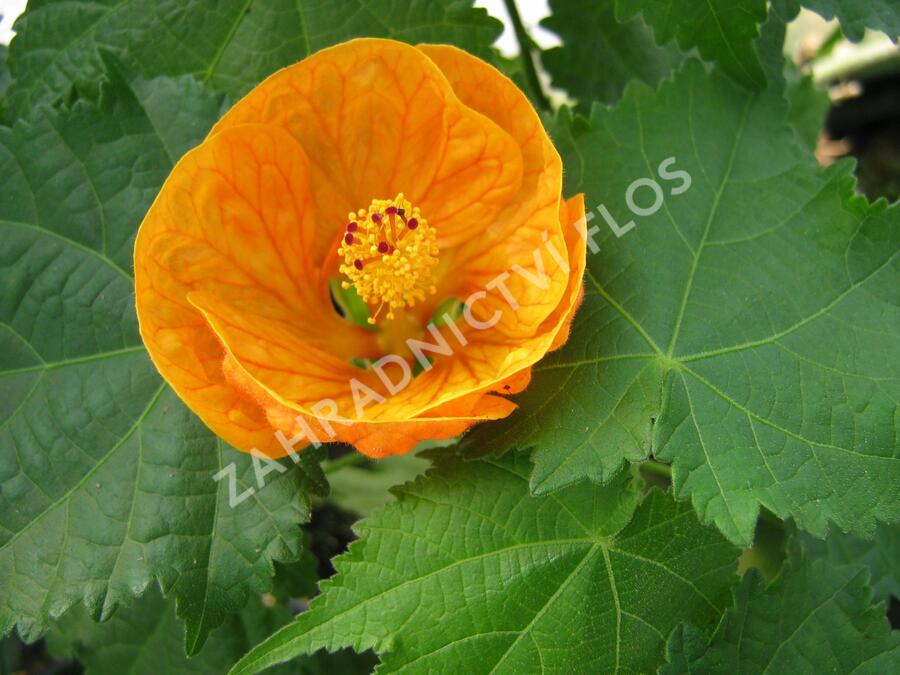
left=5, top=0, right=501, bottom=120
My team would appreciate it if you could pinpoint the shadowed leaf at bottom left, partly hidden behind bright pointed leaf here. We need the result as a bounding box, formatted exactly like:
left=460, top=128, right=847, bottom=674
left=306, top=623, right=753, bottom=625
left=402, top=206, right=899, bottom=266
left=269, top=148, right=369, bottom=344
left=48, top=589, right=374, bottom=675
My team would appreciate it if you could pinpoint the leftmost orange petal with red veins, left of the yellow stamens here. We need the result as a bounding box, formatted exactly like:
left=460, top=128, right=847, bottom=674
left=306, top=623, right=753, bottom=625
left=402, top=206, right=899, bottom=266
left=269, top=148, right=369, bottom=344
left=134, top=125, right=374, bottom=450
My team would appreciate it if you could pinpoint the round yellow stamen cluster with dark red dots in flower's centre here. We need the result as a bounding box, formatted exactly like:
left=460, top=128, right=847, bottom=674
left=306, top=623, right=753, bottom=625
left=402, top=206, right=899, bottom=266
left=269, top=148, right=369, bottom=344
left=338, top=192, right=438, bottom=324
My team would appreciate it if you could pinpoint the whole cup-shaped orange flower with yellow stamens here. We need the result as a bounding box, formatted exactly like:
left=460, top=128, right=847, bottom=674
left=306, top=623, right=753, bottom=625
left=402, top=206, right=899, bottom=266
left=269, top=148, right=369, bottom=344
left=134, top=39, right=585, bottom=457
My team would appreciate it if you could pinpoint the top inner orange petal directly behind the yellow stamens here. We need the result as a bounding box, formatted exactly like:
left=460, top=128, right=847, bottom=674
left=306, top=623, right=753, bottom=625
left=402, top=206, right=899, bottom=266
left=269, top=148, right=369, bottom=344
left=211, top=38, right=522, bottom=264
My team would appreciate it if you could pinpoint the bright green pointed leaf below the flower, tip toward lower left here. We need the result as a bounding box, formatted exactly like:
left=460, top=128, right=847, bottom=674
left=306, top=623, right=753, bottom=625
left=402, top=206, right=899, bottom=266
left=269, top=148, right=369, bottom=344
left=225, top=453, right=738, bottom=675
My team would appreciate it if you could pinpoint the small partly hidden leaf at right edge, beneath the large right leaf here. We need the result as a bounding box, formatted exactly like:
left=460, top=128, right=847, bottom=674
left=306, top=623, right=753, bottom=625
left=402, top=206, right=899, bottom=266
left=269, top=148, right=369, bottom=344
left=800, top=525, right=900, bottom=600
